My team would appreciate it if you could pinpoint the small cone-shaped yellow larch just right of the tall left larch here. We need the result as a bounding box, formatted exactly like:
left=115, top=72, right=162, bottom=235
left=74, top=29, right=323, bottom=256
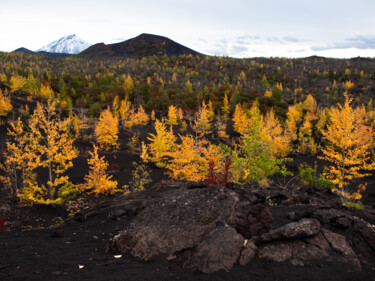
left=80, top=145, right=120, bottom=195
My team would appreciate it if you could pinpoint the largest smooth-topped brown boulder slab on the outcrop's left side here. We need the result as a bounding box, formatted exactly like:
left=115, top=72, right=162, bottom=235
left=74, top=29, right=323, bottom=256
left=112, top=188, right=238, bottom=260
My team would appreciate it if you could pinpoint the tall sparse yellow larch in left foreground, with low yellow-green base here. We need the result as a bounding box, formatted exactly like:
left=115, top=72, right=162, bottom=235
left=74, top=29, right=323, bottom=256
left=20, top=99, right=78, bottom=204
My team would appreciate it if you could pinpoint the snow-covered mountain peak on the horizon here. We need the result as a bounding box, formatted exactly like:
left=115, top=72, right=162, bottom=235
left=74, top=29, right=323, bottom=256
left=37, top=34, right=91, bottom=54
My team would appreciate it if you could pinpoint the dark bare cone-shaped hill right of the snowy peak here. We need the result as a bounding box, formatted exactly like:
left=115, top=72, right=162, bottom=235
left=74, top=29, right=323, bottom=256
left=79, top=33, right=202, bottom=58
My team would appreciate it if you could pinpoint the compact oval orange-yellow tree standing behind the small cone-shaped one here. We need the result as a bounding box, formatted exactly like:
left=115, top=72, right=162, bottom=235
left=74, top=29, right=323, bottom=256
left=95, top=108, right=118, bottom=150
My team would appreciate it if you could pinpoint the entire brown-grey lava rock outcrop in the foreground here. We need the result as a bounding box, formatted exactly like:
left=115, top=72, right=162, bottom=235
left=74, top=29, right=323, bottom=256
left=110, top=184, right=375, bottom=273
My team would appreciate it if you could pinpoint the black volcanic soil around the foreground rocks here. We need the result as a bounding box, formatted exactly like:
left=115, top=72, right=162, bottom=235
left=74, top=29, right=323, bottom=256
left=0, top=179, right=375, bottom=280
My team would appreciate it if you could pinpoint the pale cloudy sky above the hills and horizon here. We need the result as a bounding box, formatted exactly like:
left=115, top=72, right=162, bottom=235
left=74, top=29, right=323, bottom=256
left=0, top=0, right=375, bottom=58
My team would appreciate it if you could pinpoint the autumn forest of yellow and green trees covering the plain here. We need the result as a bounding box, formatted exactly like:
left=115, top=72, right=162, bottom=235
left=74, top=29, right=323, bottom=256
left=0, top=50, right=375, bottom=209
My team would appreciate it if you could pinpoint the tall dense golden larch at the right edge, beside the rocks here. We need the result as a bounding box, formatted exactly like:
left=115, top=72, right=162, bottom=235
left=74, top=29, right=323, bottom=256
left=322, top=93, right=375, bottom=201
